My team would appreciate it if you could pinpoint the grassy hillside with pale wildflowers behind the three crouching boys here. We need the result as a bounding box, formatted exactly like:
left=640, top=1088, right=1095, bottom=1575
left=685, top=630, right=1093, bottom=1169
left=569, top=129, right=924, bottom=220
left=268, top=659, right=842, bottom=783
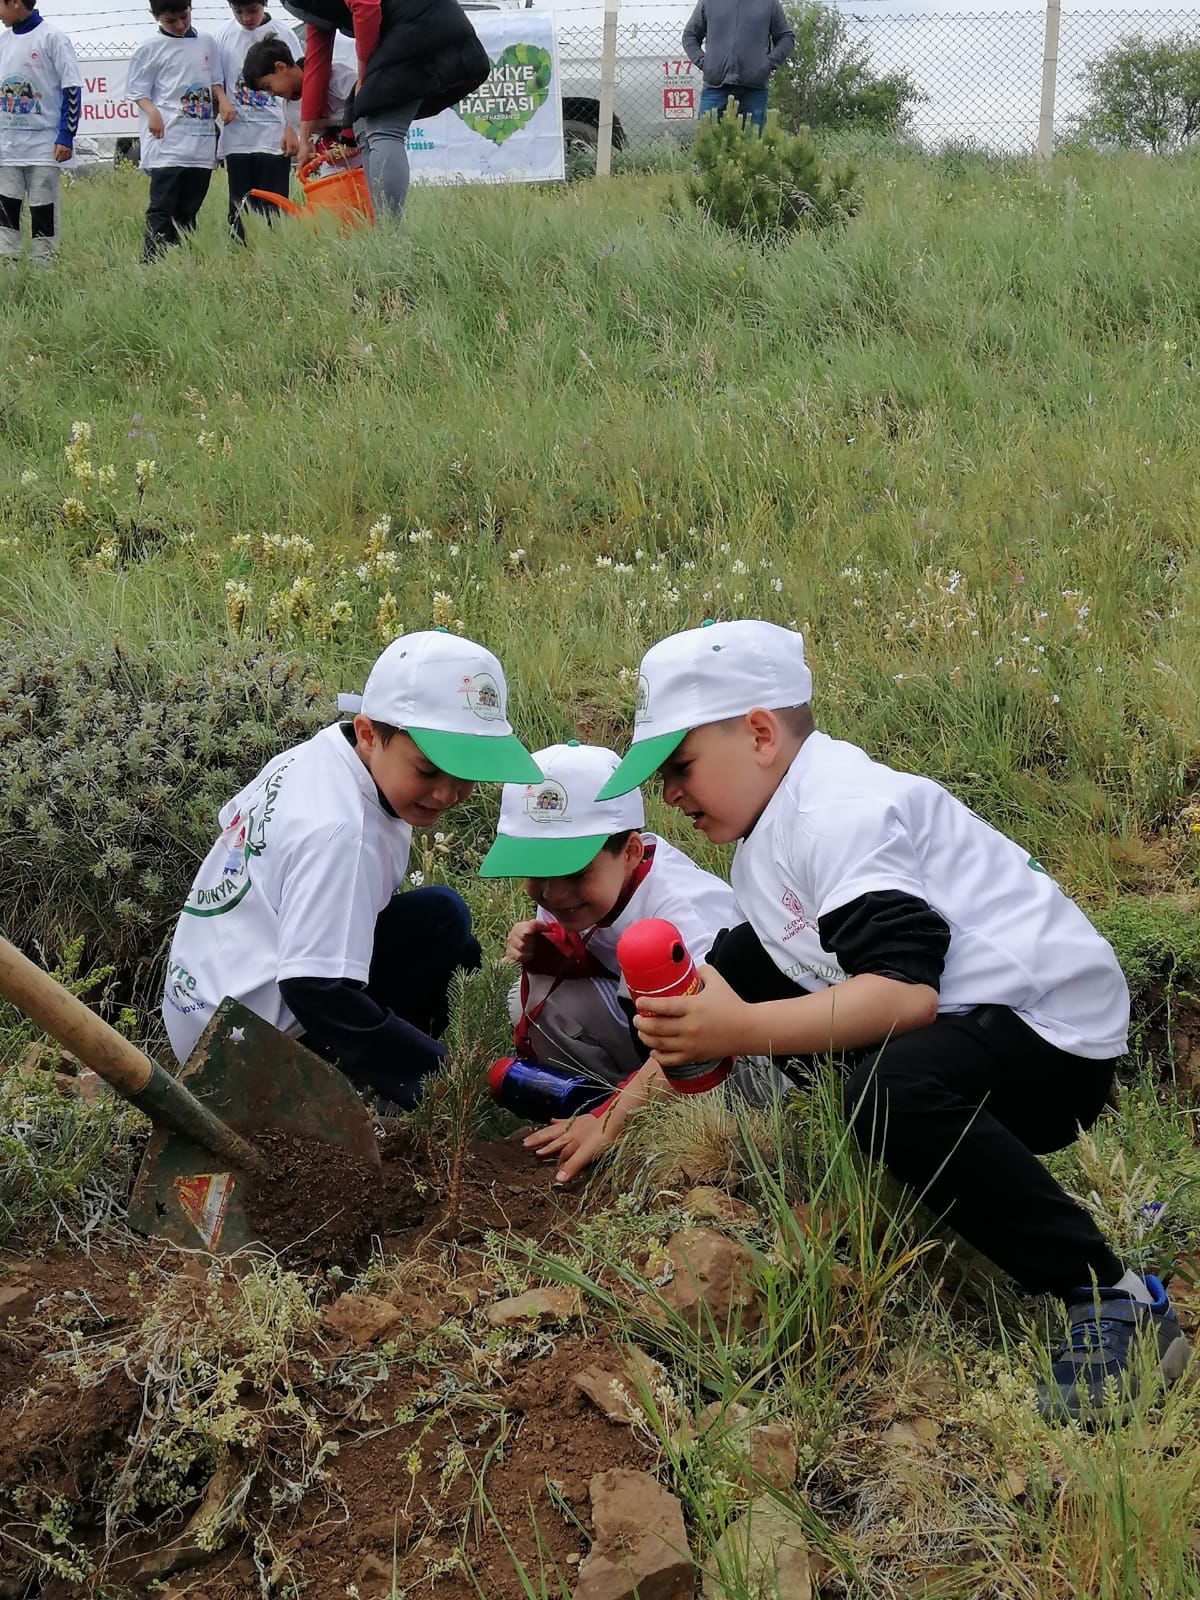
left=0, top=154, right=1200, bottom=928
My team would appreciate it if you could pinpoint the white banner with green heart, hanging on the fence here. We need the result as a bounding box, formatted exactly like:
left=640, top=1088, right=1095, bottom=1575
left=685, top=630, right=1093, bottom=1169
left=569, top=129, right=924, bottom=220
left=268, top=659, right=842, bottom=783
left=408, top=11, right=565, bottom=184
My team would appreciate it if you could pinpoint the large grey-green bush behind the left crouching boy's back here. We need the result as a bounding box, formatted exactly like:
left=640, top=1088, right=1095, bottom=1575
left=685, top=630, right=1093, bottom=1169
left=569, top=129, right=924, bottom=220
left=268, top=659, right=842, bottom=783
left=0, top=634, right=330, bottom=1000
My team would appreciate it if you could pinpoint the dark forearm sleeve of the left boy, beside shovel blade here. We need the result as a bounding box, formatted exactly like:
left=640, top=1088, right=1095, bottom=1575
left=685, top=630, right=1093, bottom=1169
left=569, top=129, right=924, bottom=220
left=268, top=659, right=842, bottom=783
left=278, top=978, right=446, bottom=1104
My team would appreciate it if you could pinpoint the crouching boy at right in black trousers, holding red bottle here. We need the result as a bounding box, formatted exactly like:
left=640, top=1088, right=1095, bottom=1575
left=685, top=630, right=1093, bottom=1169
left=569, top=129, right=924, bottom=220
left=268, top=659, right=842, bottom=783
left=565, top=621, right=1187, bottom=1416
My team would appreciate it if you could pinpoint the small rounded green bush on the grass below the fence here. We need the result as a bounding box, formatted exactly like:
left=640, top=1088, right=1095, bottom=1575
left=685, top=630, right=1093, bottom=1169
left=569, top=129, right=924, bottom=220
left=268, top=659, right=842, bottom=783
left=688, top=112, right=861, bottom=243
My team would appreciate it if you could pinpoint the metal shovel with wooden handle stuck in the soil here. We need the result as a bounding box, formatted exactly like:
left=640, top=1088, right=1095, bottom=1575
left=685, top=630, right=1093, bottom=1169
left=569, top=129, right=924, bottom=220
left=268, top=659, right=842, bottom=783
left=0, top=936, right=379, bottom=1254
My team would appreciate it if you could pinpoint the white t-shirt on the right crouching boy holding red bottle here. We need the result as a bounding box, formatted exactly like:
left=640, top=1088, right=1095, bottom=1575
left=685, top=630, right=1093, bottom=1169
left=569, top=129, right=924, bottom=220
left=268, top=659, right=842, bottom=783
left=731, top=733, right=1130, bottom=1061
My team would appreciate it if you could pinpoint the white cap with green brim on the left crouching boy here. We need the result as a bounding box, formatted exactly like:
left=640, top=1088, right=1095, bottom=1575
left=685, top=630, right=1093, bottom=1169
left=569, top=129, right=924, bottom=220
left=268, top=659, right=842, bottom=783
left=352, top=629, right=541, bottom=784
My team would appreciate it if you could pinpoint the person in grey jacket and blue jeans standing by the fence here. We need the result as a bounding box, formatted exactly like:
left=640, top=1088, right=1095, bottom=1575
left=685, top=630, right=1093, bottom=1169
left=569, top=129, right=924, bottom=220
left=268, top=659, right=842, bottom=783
left=683, top=0, right=795, bottom=133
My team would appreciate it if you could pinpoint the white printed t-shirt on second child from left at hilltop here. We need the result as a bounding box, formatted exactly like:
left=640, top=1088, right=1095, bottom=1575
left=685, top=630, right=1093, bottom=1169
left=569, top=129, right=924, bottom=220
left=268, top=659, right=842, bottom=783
left=125, top=32, right=221, bottom=173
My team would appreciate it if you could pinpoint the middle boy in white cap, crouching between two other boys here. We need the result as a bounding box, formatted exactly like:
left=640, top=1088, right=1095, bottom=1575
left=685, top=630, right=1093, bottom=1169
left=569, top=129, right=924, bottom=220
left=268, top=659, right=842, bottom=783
left=480, top=739, right=782, bottom=1113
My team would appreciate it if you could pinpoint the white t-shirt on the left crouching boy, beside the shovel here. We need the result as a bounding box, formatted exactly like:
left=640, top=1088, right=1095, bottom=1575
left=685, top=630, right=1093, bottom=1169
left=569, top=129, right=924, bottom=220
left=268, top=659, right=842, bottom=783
left=163, top=723, right=413, bottom=1061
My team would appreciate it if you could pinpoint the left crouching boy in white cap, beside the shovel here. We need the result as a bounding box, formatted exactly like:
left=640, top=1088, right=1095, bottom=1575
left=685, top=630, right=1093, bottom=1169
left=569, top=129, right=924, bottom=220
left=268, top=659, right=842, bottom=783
left=163, top=630, right=539, bottom=1107
